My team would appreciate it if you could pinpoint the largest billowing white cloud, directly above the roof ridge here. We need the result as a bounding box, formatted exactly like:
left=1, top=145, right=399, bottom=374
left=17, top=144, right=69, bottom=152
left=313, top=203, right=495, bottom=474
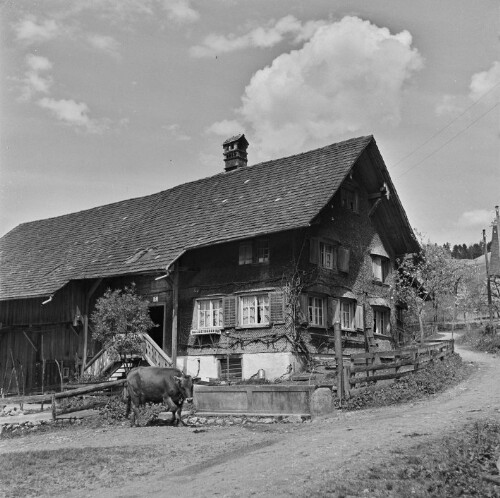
left=211, top=17, right=423, bottom=160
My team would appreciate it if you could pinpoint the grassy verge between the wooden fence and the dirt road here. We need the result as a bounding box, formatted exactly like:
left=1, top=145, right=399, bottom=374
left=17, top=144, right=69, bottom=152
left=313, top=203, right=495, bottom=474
left=336, top=353, right=473, bottom=410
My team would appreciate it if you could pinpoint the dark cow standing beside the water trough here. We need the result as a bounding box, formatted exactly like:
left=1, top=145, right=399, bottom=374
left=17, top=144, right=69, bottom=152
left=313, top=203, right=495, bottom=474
left=125, top=367, right=193, bottom=427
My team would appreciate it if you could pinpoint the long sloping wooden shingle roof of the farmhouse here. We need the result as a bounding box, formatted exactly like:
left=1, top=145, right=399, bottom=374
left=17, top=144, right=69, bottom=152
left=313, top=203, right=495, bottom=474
left=0, top=136, right=412, bottom=300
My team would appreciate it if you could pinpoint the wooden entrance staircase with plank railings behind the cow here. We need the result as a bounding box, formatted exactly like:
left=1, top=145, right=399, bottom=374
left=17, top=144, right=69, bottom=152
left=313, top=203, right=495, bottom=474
left=84, top=334, right=173, bottom=380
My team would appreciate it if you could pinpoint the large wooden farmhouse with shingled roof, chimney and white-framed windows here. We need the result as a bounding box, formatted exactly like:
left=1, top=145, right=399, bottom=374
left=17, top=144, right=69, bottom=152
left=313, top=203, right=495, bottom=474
left=0, top=135, right=419, bottom=391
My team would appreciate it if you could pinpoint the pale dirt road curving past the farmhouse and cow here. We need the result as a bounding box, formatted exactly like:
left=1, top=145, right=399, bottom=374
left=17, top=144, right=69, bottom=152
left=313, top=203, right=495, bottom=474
left=0, top=342, right=500, bottom=498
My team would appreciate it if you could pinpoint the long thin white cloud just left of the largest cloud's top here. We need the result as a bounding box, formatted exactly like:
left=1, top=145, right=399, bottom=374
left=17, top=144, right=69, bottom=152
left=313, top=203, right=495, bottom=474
left=190, top=15, right=325, bottom=57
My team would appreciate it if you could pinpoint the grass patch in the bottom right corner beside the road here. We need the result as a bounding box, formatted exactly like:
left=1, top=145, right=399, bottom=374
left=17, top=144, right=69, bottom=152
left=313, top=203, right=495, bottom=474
left=307, top=420, right=500, bottom=498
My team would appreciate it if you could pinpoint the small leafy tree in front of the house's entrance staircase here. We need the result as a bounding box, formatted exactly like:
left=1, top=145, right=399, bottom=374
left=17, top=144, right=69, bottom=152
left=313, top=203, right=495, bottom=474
left=91, top=285, right=155, bottom=361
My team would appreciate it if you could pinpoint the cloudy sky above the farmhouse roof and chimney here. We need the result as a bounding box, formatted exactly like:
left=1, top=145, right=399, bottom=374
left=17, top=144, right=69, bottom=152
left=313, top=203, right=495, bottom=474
left=0, top=0, right=500, bottom=245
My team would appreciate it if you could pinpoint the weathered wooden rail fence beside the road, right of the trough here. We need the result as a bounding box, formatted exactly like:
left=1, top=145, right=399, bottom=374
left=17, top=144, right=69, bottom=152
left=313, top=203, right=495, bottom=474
left=337, top=340, right=454, bottom=398
